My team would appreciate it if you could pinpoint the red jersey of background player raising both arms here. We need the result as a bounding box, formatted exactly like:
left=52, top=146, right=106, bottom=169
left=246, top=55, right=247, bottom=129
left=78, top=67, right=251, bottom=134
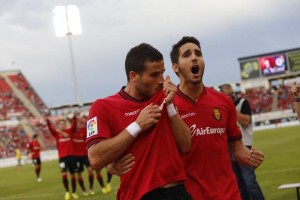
left=46, top=117, right=76, bottom=158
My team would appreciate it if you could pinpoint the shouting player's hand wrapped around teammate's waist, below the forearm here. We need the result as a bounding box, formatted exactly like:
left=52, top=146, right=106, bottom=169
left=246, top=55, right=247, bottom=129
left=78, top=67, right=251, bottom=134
left=107, top=154, right=135, bottom=176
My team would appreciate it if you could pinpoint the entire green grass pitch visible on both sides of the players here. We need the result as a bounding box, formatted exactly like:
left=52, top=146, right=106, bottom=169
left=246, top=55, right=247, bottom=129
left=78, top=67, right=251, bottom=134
left=0, top=126, right=300, bottom=200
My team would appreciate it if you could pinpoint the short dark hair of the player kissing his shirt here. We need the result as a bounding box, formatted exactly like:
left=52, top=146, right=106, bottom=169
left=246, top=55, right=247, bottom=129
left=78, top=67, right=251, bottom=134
left=125, top=43, right=164, bottom=81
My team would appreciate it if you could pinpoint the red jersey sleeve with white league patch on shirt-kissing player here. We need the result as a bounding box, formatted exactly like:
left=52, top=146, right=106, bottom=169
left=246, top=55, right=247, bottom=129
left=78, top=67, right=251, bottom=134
left=86, top=100, right=111, bottom=148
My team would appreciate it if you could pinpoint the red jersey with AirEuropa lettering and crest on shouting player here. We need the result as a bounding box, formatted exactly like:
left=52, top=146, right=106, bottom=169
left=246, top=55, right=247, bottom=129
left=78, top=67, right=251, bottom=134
left=174, top=88, right=242, bottom=200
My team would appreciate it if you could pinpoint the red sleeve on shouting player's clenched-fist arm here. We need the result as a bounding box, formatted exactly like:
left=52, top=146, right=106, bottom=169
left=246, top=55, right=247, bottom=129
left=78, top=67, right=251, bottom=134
left=227, top=97, right=242, bottom=141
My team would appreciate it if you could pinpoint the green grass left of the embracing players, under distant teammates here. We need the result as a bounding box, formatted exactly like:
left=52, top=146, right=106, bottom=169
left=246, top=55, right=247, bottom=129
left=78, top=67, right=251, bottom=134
left=0, top=160, right=119, bottom=200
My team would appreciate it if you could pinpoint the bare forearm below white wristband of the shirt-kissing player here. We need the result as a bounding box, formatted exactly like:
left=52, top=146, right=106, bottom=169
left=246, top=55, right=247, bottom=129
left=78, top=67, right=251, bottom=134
left=88, top=129, right=134, bottom=170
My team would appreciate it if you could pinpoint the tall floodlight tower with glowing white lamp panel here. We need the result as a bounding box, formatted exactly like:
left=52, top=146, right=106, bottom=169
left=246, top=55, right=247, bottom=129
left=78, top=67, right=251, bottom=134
left=53, top=5, right=82, bottom=106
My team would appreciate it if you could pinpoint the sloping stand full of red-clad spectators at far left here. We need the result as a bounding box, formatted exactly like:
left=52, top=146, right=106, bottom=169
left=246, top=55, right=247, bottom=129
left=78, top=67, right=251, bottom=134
left=0, top=70, right=55, bottom=158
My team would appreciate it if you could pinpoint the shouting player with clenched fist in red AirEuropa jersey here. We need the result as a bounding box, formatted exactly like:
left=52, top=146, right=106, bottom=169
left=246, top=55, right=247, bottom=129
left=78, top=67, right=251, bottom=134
left=170, top=37, right=264, bottom=200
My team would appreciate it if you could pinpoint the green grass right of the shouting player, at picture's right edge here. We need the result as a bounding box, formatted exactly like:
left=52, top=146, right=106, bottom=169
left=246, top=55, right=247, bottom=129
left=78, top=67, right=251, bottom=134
left=254, top=126, right=300, bottom=200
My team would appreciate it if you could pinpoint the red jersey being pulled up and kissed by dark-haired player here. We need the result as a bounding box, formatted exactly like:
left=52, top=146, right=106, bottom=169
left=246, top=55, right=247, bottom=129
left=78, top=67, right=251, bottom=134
left=86, top=90, right=186, bottom=200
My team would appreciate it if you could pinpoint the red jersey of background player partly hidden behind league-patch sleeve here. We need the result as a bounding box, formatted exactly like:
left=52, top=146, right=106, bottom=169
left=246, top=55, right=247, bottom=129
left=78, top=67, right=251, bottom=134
left=72, top=126, right=87, bottom=156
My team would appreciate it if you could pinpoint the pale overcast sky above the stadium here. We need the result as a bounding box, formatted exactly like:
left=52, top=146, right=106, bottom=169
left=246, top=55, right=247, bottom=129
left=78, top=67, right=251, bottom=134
left=0, top=0, right=300, bottom=106
